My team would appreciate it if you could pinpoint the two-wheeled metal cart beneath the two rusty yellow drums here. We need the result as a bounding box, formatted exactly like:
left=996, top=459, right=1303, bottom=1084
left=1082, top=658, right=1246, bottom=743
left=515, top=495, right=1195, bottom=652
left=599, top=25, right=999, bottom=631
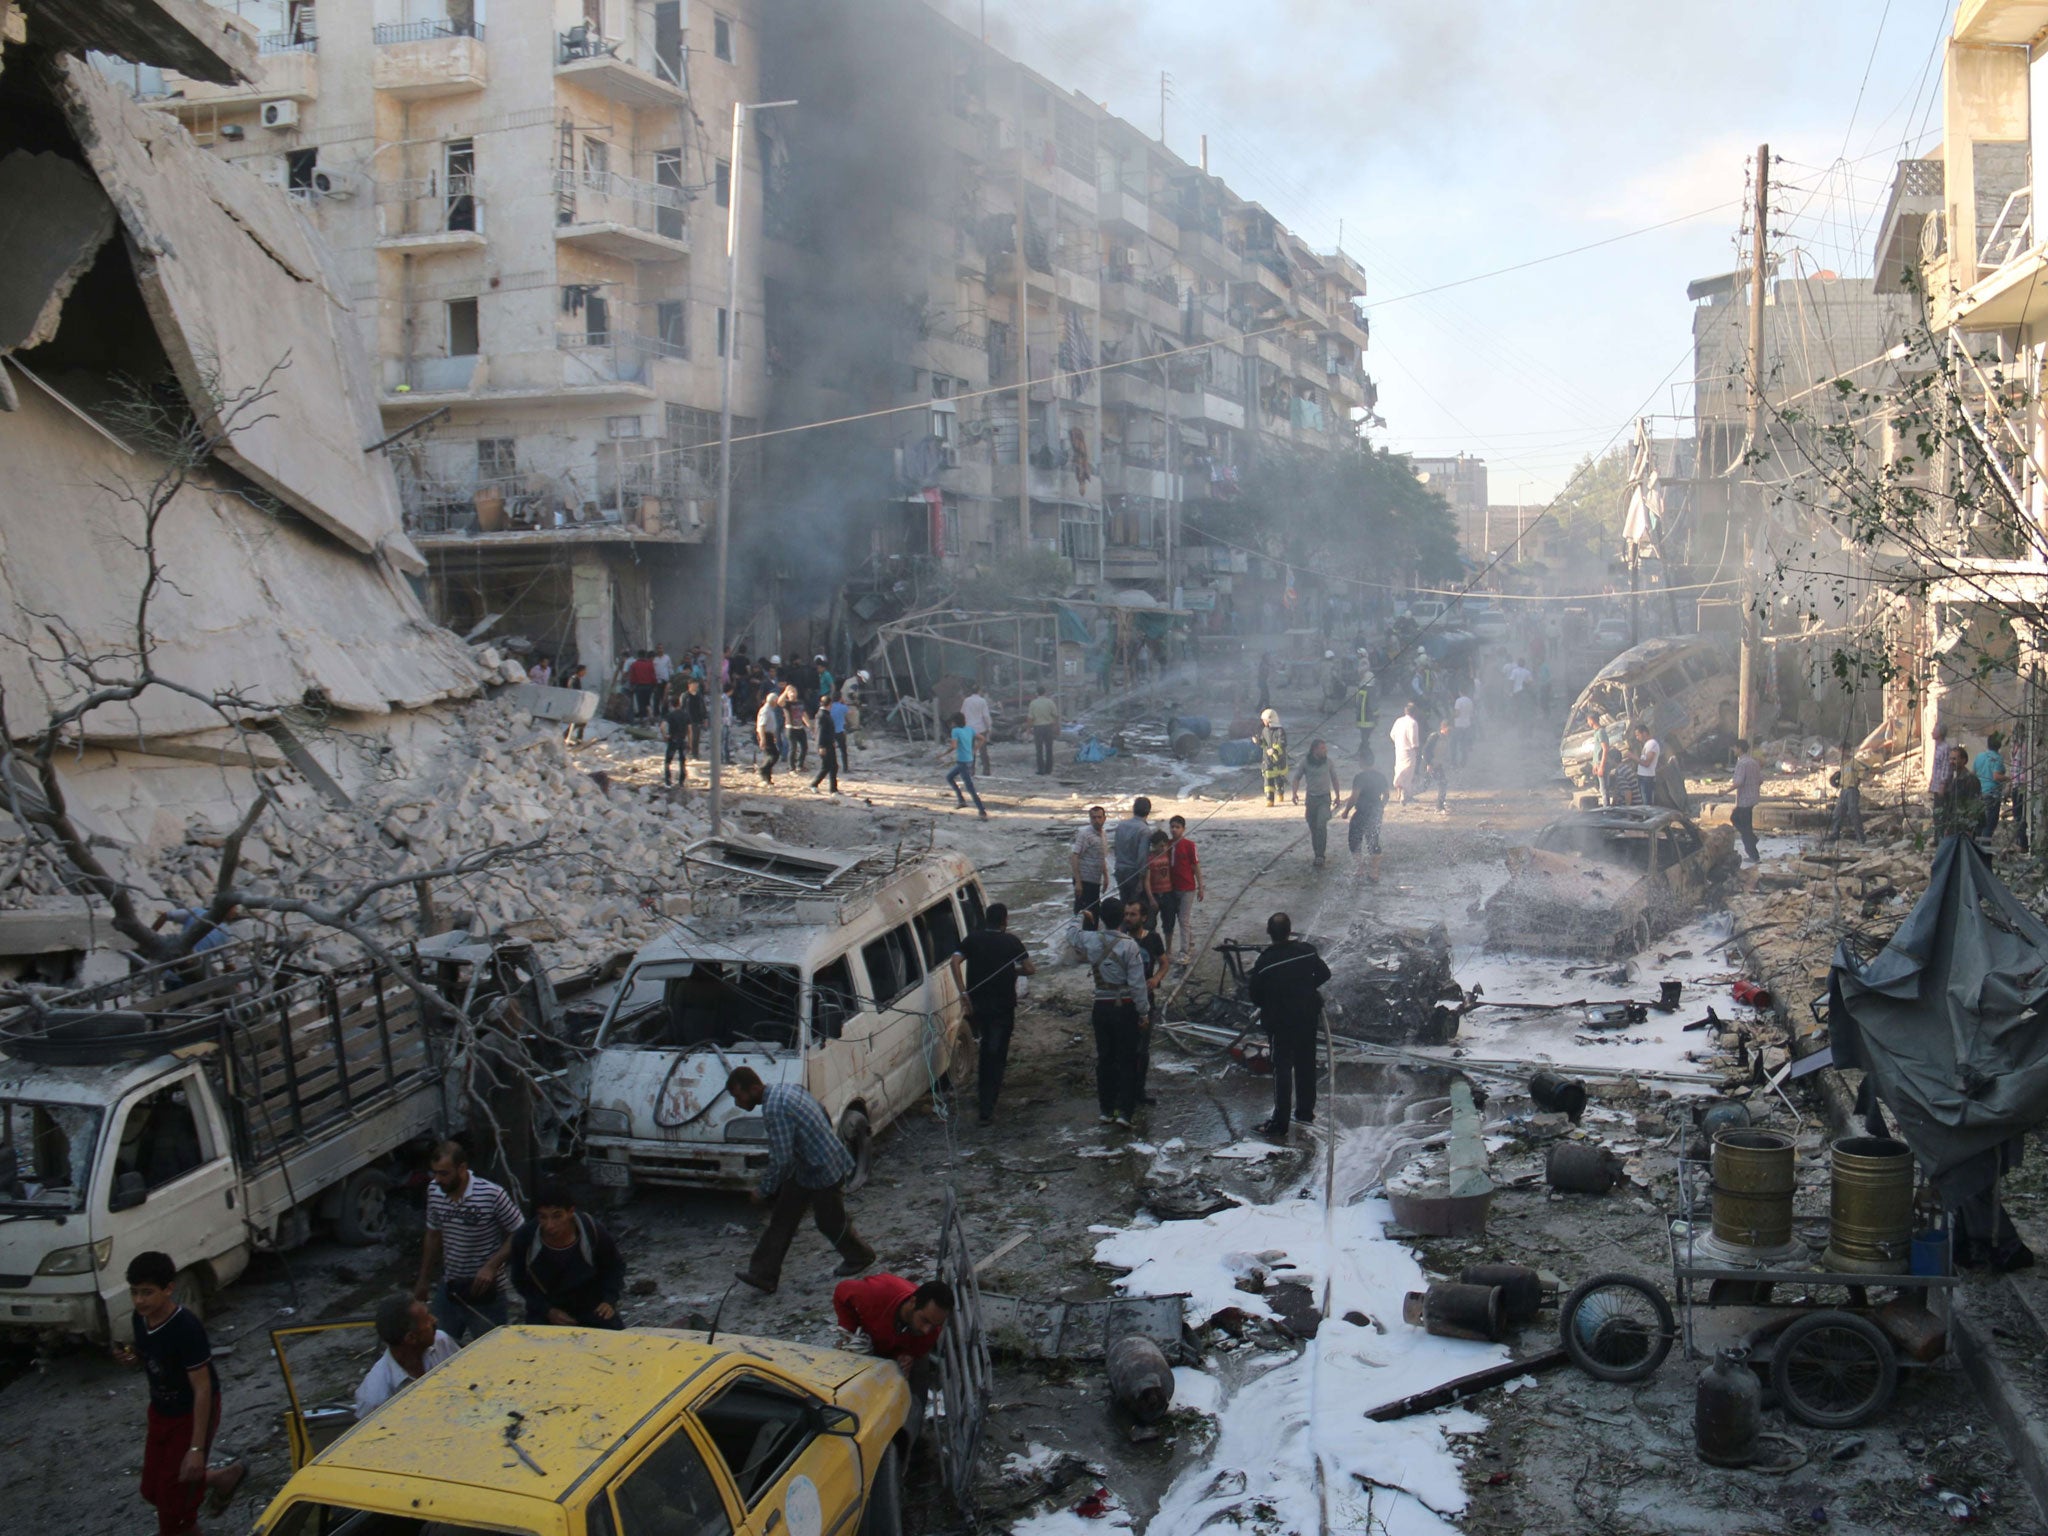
left=1559, top=1130, right=1956, bottom=1430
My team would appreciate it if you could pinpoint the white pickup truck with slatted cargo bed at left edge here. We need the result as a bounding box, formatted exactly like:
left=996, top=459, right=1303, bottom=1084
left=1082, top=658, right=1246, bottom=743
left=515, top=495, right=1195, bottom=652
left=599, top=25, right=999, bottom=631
left=0, top=944, right=551, bottom=1341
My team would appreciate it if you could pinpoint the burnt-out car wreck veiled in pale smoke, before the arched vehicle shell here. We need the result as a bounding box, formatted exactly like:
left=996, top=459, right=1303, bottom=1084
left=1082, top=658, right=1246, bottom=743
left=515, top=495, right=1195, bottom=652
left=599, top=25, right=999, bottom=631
left=1485, top=805, right=1737, bottom=961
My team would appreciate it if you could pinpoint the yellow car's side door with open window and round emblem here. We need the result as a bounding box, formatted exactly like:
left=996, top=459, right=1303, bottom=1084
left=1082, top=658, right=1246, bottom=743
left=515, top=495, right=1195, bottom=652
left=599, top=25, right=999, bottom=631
left=688, top=1366, right=862, bottom=1536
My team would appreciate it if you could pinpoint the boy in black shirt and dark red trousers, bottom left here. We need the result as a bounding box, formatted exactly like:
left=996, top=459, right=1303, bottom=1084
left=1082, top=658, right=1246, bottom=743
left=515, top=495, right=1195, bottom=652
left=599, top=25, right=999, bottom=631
left=117, top=1251, right=248, bottom=1536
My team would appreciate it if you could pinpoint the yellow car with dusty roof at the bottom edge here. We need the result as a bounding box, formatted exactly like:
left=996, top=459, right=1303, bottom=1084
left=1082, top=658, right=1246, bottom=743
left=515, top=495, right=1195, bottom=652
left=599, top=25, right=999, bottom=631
left=256, top=1327, right=909, bottom=1536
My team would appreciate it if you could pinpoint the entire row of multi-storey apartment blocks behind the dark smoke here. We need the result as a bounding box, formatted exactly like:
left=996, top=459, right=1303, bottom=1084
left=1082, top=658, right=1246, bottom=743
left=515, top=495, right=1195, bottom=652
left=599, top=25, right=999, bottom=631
left=106, top=0, right=1376, bottom=676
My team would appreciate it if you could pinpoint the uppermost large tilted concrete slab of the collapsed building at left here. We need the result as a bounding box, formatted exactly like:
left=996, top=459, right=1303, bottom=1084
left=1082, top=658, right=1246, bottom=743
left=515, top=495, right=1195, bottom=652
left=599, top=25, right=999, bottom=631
left=53, top=59, right=426, bottom=571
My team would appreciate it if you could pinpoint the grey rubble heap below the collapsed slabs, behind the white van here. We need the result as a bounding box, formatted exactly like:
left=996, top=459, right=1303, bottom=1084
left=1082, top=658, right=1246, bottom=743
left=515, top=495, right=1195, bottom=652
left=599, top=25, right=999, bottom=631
left=0, top=700, right=705, bottom=967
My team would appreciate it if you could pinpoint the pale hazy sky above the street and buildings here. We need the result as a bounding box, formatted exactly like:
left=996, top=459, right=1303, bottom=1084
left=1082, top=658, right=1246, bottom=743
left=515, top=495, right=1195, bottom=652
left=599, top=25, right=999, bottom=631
left=952, top=0, right=1952, bottom=504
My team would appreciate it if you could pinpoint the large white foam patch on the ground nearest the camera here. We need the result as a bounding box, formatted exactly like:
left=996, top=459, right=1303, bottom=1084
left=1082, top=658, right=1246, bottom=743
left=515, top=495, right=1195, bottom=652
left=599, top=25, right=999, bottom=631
left=1089, top=1198, right=1507, bottom=1536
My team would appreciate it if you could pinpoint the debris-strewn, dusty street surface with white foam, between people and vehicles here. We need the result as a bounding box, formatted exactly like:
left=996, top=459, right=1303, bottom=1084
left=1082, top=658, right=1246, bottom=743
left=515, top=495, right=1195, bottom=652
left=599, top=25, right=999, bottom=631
left=0, top=643, right=2038, bottom=1536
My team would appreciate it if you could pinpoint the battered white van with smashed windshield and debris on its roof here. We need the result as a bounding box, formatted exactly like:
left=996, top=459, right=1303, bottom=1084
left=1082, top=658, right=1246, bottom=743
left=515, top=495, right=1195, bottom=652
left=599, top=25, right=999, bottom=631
left=582, top=838, right=985, bottom=1192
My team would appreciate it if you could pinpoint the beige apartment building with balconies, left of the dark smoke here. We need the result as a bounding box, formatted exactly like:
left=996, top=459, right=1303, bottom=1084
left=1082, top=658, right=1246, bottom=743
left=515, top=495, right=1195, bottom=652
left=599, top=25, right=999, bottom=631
left=135, top=0, right=766, bottom=676
